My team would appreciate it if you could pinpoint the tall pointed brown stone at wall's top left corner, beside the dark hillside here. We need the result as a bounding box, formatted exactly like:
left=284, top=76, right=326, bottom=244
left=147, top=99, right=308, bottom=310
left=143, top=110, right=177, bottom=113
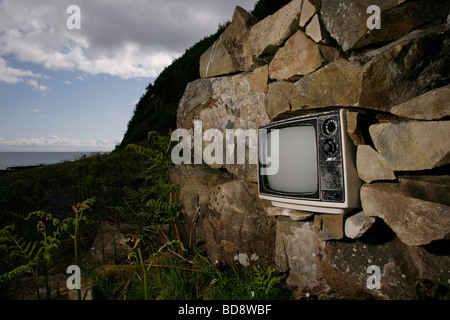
left=200, top=6, right=257, bottom=78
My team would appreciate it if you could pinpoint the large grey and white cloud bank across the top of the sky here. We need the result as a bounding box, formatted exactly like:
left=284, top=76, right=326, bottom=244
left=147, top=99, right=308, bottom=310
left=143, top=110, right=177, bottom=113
left=0, top=0, right=256, bottom=79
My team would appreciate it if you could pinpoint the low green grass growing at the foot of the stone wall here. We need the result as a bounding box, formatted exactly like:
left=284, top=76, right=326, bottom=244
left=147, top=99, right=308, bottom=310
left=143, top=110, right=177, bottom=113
left=94, top=254, right=292, bottom=300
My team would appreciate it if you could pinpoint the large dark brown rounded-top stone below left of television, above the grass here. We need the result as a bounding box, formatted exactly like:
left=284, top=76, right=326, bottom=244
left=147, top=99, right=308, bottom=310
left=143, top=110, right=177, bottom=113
left=204, top=180, right=275, bottom=267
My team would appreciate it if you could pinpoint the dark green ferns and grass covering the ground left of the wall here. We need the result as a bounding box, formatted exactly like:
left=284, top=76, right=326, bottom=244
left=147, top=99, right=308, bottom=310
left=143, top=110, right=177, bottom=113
left=0, top=132, right=290, bottom=300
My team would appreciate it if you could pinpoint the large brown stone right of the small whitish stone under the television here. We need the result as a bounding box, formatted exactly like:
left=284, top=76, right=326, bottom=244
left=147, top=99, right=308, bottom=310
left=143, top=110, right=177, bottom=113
left=361, top=183, right=450, bottom=246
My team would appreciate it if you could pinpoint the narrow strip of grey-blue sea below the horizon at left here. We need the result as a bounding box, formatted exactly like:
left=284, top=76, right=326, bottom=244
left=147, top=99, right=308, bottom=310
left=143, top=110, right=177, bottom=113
left=0, top=152, right=97, bottom=170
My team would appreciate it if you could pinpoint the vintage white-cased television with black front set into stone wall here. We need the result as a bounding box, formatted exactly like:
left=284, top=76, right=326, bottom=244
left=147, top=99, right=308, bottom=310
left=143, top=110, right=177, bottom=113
left=258, top=109, right=361, bottom=214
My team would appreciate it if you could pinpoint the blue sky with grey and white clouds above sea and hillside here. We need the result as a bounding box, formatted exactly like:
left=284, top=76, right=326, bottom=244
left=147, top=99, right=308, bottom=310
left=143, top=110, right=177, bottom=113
left=0, top=0, right=257, bottom=152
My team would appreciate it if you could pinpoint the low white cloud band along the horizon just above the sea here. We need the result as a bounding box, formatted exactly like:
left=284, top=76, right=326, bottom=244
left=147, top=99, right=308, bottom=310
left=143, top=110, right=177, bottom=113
left=0, top=136, right=122, bottom=152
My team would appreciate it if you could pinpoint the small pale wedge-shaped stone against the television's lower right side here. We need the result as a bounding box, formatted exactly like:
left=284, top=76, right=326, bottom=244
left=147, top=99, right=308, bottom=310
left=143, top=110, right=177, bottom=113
left=356, top=145, right=396, bottom=183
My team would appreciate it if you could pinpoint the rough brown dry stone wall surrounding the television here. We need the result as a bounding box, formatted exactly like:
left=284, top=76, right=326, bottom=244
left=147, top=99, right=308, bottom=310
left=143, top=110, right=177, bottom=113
left=170, top=0, right=450, bottom=299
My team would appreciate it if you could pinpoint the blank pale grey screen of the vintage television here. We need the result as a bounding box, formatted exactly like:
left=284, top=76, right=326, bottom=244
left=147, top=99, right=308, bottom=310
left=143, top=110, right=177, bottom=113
left=267, top=125, right=318, bottom=193
